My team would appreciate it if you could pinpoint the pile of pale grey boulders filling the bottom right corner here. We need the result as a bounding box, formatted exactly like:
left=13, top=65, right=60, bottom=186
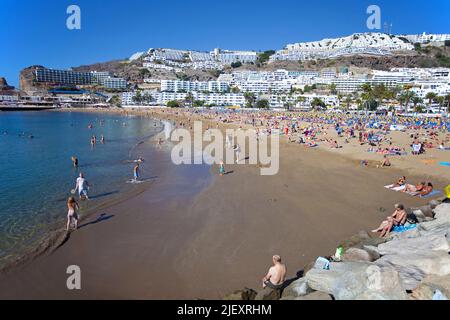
left=224, top=202, right=450, bottom=300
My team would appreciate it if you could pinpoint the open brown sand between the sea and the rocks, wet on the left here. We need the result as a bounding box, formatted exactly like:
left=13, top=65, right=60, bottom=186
left=0, top=108, right=450, bottom=299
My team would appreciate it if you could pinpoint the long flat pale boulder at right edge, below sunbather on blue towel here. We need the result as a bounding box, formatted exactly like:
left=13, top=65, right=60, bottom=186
left=378, top=235, right=450, bottom=255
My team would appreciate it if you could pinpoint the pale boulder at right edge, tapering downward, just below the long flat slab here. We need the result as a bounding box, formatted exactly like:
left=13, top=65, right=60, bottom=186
left=375, top=249, right=450, bottom=290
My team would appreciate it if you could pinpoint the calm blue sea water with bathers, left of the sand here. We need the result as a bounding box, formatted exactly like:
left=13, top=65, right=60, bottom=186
left=0, top=111, right=161, bottom=264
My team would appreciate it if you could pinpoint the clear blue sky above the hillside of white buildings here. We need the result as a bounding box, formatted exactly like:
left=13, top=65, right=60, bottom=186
left=0, top=0, right=450, bottom=85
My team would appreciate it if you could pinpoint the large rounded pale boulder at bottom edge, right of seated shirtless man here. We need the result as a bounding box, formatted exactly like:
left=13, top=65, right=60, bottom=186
left=306, top=262, right=407, bottom=300
